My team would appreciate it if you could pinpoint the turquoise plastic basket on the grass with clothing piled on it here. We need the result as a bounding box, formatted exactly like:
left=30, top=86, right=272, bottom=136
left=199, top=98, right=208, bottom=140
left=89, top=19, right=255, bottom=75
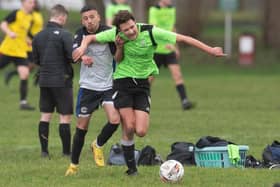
left=194, top=145, right=249, bottom=168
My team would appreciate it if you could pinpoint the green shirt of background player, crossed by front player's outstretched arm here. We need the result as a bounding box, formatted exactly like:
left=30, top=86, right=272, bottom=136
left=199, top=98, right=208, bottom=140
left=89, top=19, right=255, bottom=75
left=149, top=6, right=176, bottom=54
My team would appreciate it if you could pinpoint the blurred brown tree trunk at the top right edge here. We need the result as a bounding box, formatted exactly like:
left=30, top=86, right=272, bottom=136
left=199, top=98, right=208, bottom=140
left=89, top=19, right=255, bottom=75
left=263, top=0, right=280, bottom=48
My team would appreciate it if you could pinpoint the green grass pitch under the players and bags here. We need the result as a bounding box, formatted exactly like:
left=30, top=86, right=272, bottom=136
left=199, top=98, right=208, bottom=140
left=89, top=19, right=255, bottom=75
left=0, top=48, right=280, bottom=187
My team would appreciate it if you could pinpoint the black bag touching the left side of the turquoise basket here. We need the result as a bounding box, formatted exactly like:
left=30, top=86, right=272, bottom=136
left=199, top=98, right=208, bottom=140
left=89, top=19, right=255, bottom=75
left=167, top=142, right=195, bottom=165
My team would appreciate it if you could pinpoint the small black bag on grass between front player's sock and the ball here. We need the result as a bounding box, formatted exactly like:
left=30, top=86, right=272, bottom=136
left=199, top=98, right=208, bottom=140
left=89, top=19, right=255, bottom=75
left=137, top=145, right=163, bottom=166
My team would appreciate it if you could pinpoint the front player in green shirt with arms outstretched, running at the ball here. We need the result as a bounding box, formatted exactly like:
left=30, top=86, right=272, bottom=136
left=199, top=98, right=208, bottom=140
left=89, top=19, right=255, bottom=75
left=73, top=10, right=225, bottom=175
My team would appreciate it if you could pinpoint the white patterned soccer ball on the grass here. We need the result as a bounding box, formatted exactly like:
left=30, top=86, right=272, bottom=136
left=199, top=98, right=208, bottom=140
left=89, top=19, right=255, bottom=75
left=159, top=160, right=184, bottom=183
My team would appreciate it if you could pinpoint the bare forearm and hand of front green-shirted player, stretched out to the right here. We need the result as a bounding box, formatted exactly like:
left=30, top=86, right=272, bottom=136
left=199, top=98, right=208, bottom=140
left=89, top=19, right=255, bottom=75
left=176, top=34, right=226, bottom=57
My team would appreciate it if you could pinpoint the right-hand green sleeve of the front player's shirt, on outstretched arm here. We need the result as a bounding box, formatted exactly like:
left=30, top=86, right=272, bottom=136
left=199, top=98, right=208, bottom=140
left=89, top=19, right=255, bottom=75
left=152, top=27, right=177, bottom=44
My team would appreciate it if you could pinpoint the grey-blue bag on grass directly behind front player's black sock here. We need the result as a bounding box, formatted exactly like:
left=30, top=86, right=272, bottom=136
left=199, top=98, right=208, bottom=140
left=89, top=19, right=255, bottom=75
left=107, top=144, right=140, bottom=165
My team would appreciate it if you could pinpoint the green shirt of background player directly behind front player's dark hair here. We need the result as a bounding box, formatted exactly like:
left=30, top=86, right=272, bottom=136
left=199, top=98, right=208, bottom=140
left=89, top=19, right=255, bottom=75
left=105, top=0, right=132, bottom=26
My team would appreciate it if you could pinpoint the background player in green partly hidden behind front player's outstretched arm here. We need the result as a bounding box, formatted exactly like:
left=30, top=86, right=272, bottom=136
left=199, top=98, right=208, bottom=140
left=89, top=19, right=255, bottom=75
left=149, top=0, right=194, bottom=110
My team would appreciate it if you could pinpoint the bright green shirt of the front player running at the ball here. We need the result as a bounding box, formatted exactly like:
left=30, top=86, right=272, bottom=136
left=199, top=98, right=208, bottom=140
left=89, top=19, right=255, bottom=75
left=96, top=23, right=176, bottom=79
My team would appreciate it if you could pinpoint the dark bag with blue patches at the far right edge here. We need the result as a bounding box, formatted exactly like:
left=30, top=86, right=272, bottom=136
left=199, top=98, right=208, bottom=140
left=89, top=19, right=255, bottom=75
left=262, top=140, right=280, bottom=167
